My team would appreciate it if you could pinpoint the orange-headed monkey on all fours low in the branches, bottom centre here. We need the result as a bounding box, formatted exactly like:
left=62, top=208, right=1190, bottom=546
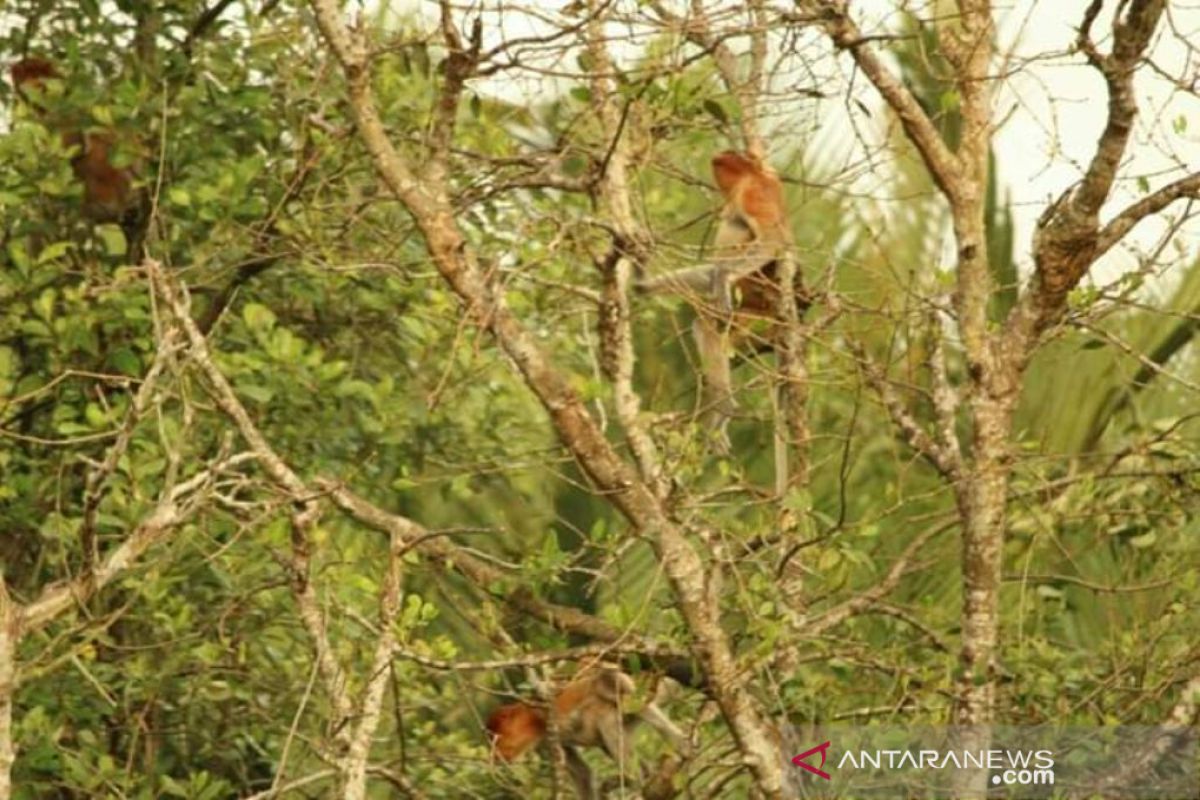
left=487, top=666, right=689, bottom=800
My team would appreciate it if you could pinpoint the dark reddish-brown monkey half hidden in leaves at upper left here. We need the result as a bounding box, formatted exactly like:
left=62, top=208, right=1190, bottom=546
left=8, top=58, right=137, bottom=227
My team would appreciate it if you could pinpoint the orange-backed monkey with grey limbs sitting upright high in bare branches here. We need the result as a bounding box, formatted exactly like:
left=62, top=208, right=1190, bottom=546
left=641, top=150, right=808, bottom=450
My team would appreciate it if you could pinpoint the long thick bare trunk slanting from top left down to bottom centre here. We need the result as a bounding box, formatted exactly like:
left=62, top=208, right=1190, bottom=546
left=304, top=0, right=782, bottom=798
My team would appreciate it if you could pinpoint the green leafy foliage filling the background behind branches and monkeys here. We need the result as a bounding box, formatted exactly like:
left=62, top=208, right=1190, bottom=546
left=0, top=0, right=1200, bottom=799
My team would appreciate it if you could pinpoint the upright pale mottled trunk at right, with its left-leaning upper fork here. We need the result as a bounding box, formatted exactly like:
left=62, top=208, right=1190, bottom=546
left=805, top=0, right=1003, bottom=724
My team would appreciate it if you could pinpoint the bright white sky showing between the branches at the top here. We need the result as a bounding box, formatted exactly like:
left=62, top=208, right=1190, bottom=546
left=397, top=0, right=1200, bottom=285
